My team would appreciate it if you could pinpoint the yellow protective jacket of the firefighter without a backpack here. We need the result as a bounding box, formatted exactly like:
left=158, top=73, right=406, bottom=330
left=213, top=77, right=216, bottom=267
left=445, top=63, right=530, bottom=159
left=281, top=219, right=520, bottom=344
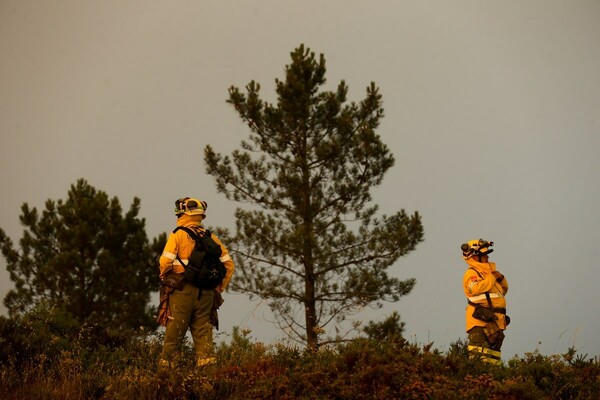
left=463, top=258, right=508, bottom=332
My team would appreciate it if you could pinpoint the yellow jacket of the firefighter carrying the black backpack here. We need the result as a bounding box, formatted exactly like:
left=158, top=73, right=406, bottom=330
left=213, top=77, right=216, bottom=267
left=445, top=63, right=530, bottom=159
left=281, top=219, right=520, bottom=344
left=159, top=215, right=235, bottom=292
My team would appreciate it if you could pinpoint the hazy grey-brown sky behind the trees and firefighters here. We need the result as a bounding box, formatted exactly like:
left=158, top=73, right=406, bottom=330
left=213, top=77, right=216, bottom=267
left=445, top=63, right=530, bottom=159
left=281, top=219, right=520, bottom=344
left=0, top=0, right=600, bottom=359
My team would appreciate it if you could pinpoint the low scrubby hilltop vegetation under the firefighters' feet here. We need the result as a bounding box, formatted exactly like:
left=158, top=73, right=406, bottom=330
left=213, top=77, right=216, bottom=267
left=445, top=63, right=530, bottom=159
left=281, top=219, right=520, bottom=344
left=0, top=307, right=600, bottom=400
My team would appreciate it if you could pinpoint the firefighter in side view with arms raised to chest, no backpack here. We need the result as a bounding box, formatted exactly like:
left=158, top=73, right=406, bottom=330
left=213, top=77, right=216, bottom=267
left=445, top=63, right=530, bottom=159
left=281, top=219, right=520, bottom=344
left=461, top=239, right=510, bottom=365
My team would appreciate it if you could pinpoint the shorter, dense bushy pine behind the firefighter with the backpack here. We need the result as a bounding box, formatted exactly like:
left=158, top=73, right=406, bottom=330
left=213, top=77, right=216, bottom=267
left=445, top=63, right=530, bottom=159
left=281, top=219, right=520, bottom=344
left=0, top=179, right=166, bottom=329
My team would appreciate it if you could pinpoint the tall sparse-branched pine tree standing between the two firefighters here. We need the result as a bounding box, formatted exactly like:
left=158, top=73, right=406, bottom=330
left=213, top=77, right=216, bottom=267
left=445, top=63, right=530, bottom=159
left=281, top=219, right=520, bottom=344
left=204, top=45, right=423, bottom=349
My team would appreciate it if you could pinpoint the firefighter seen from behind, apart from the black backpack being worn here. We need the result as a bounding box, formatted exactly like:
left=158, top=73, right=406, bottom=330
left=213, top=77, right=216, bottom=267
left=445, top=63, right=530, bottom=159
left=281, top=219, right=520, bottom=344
left=157, top=197, right=234, bottom=369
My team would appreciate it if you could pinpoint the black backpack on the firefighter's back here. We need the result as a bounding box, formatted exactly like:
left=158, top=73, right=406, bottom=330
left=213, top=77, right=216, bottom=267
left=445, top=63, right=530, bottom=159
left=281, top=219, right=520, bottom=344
left=173, top=226, right=227, bottom=290
